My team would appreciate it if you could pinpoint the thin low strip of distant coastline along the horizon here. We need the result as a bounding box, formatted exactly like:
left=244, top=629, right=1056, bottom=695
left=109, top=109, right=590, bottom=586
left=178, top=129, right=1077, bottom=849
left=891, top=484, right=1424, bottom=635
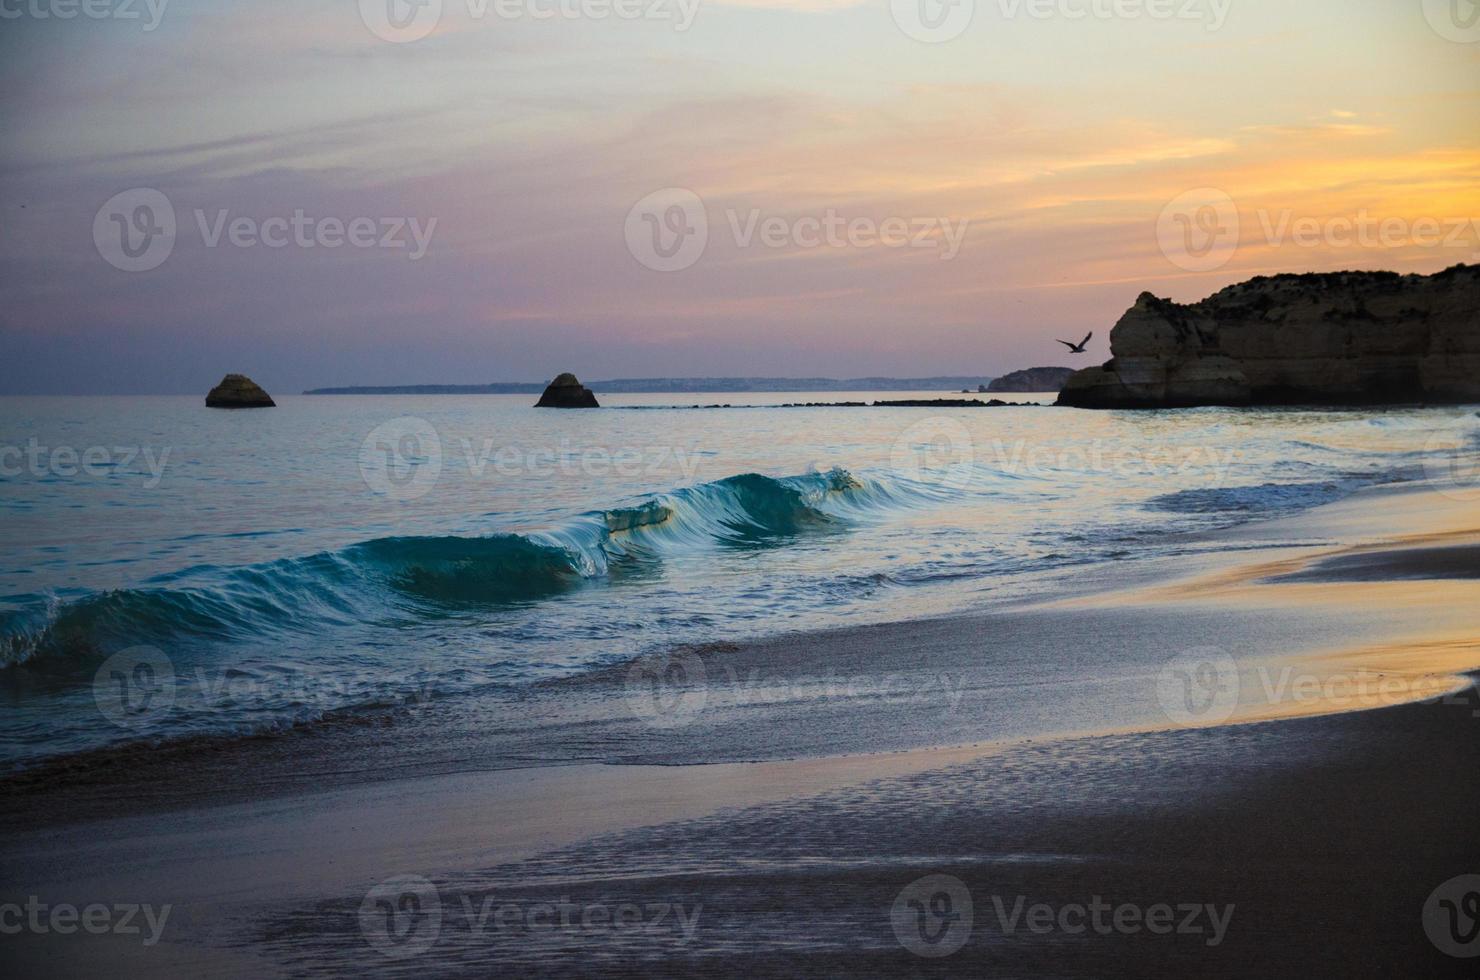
left=303, top=375, right=993, bottom=395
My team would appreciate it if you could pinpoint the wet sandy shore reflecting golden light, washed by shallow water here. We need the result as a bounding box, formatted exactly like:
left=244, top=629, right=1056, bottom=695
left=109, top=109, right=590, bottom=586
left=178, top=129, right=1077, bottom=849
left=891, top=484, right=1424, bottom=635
left=0, top=487, right=1480, bottom=977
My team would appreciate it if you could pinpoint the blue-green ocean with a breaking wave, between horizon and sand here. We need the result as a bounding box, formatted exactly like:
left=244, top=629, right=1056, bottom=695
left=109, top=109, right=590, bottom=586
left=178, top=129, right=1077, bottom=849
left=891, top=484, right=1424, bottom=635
left=0, top=392, right=1480, bottom=770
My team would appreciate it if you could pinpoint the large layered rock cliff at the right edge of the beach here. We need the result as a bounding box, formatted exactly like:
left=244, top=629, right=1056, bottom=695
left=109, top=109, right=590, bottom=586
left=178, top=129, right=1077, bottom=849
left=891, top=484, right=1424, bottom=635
left=1058, top=265, right=1480, bottom=409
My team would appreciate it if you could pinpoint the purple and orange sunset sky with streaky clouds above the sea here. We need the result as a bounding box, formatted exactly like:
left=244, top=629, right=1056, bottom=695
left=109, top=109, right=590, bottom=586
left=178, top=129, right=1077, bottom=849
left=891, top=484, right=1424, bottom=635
left=0, top=0, right=1480, bottom=394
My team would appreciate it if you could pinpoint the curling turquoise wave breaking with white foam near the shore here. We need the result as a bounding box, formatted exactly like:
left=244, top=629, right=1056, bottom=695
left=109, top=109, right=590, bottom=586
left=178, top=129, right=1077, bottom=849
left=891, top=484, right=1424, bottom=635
left=0, top=469, right=912, bottom=672
